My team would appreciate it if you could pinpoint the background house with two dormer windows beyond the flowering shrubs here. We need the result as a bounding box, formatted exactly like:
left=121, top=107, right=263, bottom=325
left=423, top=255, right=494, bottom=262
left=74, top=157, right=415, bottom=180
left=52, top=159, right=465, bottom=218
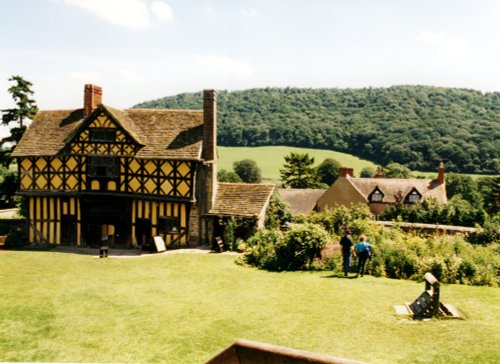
left=316, top=163, right=447, bottom=215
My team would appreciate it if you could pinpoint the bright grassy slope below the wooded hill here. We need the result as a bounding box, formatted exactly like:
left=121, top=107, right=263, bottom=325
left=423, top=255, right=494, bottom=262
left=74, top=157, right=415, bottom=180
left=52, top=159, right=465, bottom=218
left=217, top=146, right=376, bottom=181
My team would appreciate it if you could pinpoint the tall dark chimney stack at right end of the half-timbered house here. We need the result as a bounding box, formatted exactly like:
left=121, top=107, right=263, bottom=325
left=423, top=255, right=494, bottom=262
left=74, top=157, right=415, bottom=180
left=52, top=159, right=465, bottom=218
left=203, top=90, right=217, bottom=162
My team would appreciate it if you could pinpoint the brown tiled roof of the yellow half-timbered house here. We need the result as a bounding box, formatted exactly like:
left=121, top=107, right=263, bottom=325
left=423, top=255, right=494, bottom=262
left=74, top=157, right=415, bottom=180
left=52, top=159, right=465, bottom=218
left=12, top=105, right=203, bottom=160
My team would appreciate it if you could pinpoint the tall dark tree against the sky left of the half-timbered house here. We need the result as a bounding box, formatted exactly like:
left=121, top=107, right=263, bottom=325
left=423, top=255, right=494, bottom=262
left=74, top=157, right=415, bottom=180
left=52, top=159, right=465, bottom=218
left=1, top=76, right=38, bottom=166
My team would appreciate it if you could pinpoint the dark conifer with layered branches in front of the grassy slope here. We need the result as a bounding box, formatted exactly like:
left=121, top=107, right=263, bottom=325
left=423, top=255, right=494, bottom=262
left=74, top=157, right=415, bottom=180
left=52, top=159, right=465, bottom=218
left=280, top=152, right=319, bottom=188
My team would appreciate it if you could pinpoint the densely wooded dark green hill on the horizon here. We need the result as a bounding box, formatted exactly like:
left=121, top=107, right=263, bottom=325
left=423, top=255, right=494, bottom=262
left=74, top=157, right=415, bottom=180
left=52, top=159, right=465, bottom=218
left=135, top=86, right=500, bottom=174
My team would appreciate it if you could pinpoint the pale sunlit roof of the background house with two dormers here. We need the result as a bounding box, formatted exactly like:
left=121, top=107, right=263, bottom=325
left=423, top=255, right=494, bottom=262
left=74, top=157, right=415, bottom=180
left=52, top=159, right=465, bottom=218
left=345, top=176, right=446, bottom=203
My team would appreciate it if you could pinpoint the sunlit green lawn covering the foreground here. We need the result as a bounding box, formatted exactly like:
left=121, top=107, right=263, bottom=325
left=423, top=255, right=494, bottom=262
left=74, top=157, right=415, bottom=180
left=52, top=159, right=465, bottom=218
left=0, top=251, right=500, bottom=363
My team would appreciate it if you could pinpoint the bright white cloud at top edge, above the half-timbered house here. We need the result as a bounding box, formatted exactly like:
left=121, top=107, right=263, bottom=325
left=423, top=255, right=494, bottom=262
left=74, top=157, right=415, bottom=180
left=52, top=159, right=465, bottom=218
left=62, top=0, right=173, bottom=29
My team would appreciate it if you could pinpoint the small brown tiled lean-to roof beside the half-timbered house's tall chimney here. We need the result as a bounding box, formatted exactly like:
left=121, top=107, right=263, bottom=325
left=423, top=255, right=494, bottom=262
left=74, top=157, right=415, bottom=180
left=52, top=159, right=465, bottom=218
left=209, top=182, right=275, bottom=217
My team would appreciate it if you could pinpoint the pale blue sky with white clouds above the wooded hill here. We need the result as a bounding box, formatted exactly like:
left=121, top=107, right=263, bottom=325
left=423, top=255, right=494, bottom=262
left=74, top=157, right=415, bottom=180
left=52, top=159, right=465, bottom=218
left=0, top=0, right=500, bottom=116
